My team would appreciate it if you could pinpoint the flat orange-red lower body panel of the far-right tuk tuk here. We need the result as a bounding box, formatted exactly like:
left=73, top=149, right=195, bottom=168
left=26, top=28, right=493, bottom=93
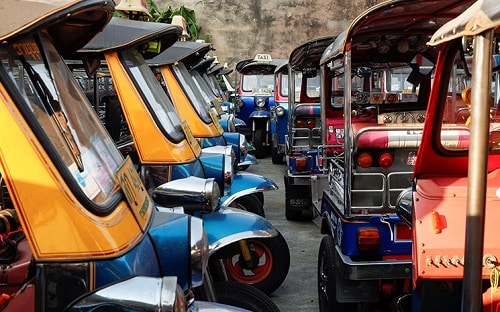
left=413, top=170, right=500, bottom=279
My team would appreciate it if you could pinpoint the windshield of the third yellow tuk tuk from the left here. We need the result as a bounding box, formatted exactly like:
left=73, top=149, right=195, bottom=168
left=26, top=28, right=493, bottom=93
left=172, top=63, right=213, bottom=124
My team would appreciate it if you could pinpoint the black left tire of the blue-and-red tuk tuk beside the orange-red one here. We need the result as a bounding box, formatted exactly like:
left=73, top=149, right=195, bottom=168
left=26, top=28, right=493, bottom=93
left=317, top=235, right=357, bottom=312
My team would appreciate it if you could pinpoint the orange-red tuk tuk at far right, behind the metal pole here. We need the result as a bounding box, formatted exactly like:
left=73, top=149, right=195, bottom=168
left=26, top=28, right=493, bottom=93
left=394, top=0, right=500, bottom=311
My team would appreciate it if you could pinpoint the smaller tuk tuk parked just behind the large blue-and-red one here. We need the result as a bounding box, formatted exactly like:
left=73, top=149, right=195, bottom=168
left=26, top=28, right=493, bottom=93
left=282, top=37, right=335, bottom=220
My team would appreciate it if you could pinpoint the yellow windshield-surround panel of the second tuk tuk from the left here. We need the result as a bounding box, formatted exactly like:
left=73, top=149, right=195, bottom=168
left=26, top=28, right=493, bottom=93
left=105, top=52, right=201, bottom=165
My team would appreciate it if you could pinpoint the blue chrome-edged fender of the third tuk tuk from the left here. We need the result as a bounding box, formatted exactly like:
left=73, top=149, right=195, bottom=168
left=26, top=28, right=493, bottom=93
left=220, top=171, right=278, bottom=206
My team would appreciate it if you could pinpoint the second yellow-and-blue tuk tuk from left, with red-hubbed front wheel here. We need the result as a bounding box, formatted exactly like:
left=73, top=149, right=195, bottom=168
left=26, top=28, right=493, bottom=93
left=73, top=18, right=290, bottom=301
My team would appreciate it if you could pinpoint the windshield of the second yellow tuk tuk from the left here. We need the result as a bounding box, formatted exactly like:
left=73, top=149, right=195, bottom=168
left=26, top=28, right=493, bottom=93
left=120, top=49, right=185, bottom=143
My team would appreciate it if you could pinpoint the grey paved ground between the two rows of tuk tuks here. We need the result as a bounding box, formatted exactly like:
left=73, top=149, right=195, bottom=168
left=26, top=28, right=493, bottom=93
left=247, top=157, right=322, bottom=312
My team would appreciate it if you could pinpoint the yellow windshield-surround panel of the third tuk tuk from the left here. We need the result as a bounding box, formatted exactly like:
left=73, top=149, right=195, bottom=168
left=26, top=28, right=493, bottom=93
left=160, top=65, right=223, bottom=138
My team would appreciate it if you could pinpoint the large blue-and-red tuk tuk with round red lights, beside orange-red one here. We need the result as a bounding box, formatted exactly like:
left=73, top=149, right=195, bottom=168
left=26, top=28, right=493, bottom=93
left=311, top=0, right=472, bottom=311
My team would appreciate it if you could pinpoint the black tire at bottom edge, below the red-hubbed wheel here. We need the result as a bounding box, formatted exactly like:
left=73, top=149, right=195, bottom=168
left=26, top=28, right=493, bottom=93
left=214, top=281, right=280, bottom=312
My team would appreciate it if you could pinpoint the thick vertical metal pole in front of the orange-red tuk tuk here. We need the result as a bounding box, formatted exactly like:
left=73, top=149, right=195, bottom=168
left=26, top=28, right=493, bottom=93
left=462, top=30, right=493, bottom=312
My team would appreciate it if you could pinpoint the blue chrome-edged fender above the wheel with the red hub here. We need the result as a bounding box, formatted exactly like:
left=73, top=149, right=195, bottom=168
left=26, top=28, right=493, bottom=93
left=201, top=206, right=278, bottom=255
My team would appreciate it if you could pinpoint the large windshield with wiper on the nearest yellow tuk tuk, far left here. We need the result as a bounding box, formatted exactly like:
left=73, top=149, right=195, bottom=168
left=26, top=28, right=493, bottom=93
left=0, top=33, right=123, bottom=214
